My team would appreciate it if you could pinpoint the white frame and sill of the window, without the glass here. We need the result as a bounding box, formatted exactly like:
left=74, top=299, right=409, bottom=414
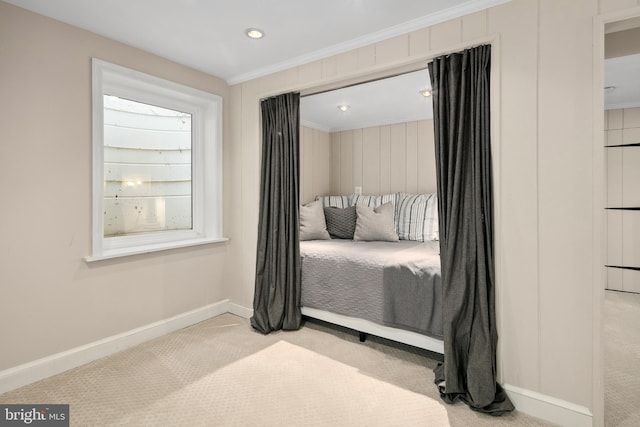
left=85, top=58, right=228, bottom=262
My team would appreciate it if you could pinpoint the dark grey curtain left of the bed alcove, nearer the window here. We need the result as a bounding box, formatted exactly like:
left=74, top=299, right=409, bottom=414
left=251, top=93, right=302, bottom=334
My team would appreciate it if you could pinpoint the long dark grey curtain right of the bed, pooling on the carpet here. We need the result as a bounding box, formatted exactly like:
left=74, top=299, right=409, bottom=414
left=429, top=45, right=513, bottom=415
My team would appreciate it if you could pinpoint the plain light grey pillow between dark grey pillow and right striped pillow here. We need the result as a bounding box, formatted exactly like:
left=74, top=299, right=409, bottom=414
left=353, top=202, right=398, bottom=242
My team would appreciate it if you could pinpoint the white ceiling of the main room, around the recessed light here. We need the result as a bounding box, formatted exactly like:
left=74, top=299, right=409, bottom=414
left=3, top=0, right=510, bottom=84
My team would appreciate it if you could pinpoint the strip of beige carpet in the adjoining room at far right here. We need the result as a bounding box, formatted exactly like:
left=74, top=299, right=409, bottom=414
left=604, top=291, right=640, bottom=427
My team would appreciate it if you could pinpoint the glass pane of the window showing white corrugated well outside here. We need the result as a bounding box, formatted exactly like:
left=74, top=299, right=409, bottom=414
left=103, top=95, right=193, bottom=237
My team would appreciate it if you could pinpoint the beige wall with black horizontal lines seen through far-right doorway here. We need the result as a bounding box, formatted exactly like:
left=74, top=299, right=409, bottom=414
left=605, top=107, right=640, bottom=293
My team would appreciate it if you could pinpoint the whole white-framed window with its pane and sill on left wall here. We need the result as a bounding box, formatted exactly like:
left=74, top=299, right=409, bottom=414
left=86, top=59, right=226, bottom=261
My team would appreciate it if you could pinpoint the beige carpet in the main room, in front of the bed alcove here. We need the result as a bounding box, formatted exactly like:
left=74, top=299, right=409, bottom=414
left=0, top=314, right=550, bottom=427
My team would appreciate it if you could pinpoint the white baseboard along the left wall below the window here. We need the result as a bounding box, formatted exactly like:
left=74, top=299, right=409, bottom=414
left=0, top=299, right=234, bottom=394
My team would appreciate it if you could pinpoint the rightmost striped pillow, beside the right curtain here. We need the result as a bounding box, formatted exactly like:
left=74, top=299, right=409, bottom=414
left=396, top=193, right=439, bottom=242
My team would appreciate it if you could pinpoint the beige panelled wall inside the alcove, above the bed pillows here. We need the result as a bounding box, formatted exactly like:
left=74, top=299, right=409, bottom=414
left=301, top=120, right=436, bottom=203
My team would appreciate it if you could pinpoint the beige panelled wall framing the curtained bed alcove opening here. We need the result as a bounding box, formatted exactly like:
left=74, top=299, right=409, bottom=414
left=231, top=0, right=638, bottom=425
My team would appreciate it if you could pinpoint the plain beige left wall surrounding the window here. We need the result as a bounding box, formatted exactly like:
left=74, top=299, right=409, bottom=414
left=0, top=2, right=233, bottom=371
